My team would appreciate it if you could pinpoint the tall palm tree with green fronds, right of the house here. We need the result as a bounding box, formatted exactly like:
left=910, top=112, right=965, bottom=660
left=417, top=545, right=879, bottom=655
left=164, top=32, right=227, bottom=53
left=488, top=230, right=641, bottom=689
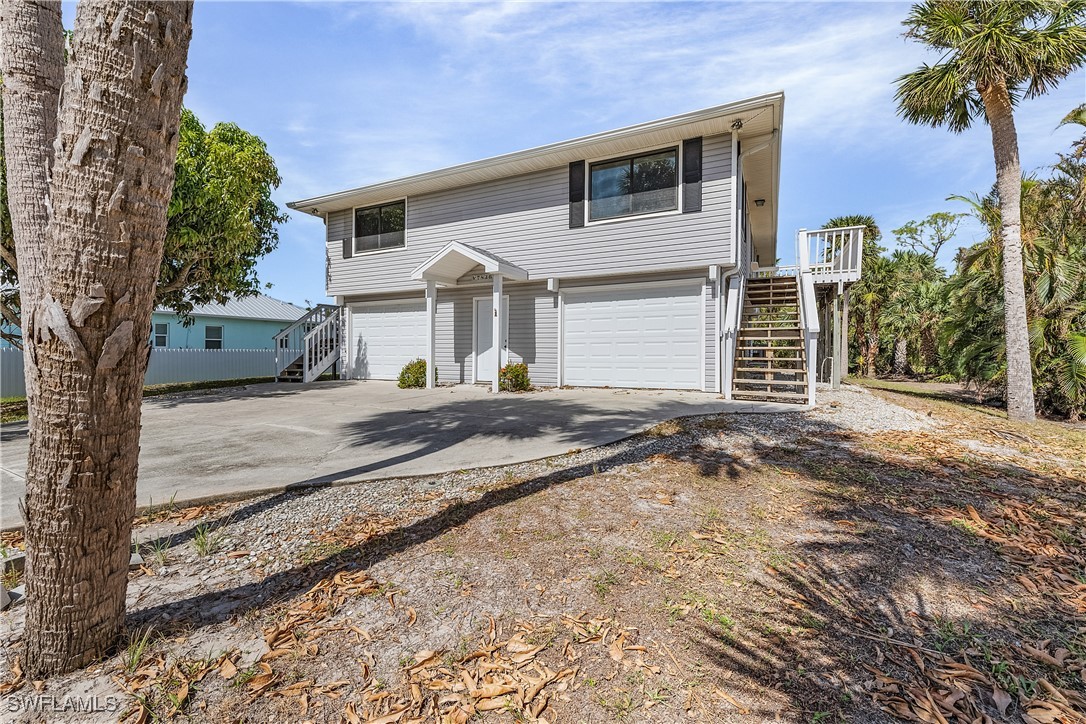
left=896, top=0, right=1086, bottom=420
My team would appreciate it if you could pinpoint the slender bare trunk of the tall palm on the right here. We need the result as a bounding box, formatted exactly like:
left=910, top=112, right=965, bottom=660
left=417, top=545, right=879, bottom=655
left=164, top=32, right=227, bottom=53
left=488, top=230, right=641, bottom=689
left=978, top=84, right=1036, bottom=421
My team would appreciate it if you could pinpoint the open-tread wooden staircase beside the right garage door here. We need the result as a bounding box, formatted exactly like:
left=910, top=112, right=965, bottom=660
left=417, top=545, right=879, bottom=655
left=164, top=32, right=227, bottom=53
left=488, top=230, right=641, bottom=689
left=732, top=277, right=808, bottom=405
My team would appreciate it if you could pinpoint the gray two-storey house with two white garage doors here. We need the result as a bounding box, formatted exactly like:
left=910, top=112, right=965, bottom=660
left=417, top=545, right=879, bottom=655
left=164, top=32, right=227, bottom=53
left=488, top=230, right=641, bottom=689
left=285, top=93, right=862, bottom=402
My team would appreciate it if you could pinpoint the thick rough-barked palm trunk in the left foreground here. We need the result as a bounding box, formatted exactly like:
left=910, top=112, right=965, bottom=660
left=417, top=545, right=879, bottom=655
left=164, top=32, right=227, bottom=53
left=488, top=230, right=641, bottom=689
left=0, top=0, right=192, bottom=678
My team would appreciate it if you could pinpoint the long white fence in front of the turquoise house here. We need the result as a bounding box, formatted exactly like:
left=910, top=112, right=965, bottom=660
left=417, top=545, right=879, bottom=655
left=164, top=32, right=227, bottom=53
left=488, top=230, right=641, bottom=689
left=0, top=347, right=275, bottom=397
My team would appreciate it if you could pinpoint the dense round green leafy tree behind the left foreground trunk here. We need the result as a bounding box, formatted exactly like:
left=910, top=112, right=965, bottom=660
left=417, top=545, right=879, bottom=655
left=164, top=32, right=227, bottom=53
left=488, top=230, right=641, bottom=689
left=0, top=104, right=287, bottom=346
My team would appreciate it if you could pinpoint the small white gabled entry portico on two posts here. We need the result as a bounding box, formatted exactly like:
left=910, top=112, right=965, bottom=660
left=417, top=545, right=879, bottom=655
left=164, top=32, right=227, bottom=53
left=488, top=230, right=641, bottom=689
left=412, top=241, right=528, bottom=392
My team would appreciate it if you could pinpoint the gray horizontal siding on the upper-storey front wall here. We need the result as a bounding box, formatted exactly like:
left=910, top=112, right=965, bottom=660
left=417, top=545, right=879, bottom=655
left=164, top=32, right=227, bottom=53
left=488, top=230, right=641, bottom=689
left=327, top=135, right=733, bottom=295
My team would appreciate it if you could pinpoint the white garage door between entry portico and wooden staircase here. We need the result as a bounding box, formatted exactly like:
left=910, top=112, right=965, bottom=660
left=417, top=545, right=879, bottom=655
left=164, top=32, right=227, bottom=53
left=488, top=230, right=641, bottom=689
left=563, top=282, right=702, bottom=390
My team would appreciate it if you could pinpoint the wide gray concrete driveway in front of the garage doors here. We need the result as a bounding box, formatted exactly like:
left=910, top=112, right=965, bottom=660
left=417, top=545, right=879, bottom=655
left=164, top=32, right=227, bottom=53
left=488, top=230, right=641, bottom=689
left=0, top=382, right=801, bottom=529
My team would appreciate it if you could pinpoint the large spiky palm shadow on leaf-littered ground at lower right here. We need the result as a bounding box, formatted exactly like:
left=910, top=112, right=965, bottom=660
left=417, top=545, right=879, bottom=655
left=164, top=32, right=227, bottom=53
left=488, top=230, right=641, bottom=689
left=673, top=425, right=1086, bottom=722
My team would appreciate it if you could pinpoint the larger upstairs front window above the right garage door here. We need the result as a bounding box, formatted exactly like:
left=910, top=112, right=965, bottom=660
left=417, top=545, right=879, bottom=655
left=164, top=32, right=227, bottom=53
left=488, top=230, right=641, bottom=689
left=589, top=149, right=679, bottom=221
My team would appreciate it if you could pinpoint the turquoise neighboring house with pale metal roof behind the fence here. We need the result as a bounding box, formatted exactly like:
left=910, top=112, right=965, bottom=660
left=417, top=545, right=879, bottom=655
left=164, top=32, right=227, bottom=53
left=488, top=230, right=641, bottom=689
left=151, top=294, right=306, bottom=350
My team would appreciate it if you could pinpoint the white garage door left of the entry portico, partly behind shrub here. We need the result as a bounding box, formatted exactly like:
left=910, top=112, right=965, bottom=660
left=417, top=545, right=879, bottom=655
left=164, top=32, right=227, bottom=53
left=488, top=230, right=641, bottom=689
left=348, top=302, right=426, bottom=380
